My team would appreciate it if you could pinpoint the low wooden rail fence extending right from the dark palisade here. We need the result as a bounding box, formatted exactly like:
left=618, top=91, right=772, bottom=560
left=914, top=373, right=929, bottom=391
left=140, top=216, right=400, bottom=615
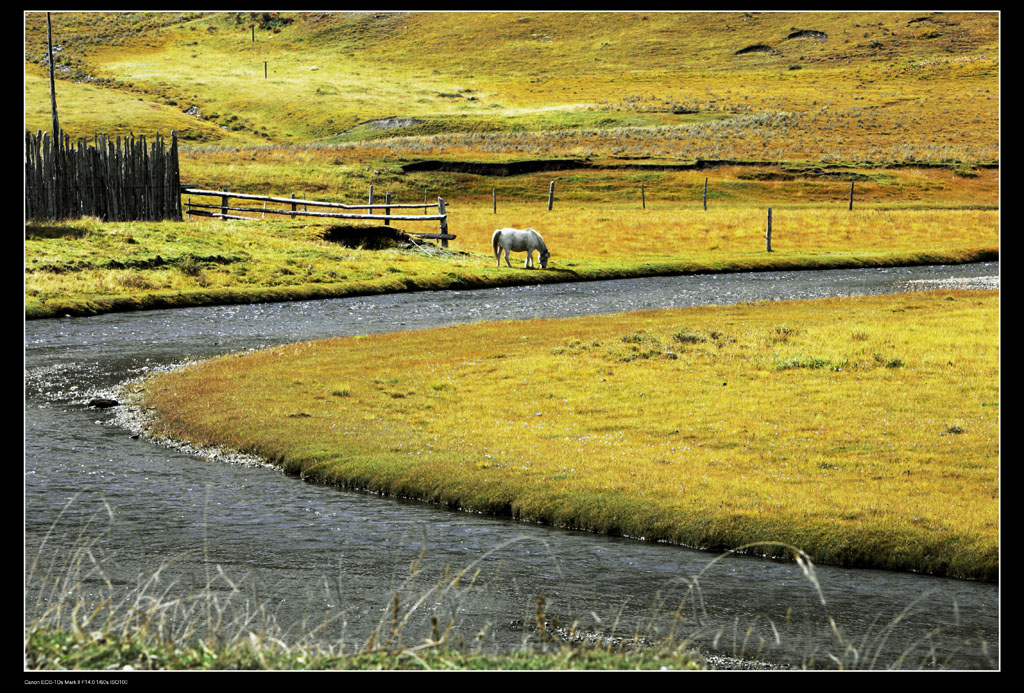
left=181, top=186, right=456, bottom=248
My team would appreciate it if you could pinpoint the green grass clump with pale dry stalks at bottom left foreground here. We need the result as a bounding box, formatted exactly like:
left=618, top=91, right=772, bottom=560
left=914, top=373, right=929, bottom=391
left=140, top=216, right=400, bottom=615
left=25, top=501, right=708, bottom=672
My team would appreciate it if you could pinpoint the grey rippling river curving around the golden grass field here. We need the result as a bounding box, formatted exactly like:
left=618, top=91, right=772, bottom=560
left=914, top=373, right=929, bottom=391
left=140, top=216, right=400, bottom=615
left=25, top=263, right=999, bottom=668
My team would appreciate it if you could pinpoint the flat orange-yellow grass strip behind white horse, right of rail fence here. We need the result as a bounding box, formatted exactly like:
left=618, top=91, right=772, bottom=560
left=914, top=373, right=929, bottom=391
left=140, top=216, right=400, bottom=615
left=451, top=204, right=999, bottom=266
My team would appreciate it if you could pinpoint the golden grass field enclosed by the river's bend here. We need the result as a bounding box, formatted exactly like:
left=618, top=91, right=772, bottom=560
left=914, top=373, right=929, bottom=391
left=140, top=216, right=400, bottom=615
left=142, top=291, right=999, bottom=579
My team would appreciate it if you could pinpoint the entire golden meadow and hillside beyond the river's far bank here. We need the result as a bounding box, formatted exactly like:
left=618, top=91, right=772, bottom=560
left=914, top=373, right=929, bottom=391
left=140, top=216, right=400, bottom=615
left=25, top=12, right=999, bottom=317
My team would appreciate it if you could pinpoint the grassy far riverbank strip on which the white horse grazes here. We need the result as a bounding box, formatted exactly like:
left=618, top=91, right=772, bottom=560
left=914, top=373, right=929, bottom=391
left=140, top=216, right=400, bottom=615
left=25, top=205, right=998, bottom=319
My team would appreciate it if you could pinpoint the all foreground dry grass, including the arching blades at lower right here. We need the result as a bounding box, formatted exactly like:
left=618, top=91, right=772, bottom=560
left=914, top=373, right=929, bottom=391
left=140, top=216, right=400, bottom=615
left=26, top=500, right=994, bottom=669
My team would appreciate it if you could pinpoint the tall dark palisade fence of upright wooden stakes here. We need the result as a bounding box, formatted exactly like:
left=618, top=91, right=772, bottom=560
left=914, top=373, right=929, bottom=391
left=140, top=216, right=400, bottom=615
left=25, top=126, right=181, bottom=221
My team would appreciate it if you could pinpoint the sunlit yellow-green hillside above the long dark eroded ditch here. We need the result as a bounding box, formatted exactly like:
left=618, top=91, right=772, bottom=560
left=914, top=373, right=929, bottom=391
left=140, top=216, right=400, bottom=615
left=26, top=12, right=999, bottom=163
